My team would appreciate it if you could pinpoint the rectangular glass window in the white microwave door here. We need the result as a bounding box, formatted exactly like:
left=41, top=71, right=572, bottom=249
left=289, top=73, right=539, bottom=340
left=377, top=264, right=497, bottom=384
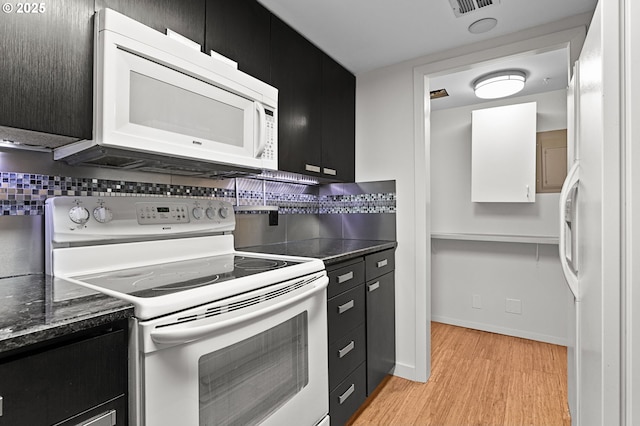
left=129, top=71, right=244, bottom=147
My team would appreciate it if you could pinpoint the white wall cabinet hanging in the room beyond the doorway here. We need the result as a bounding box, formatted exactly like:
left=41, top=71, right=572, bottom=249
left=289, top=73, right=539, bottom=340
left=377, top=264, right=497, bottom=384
left=471, top=102, right=536, bottom=203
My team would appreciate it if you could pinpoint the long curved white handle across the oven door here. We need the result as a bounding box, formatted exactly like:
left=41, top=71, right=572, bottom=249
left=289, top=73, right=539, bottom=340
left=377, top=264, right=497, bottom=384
left=150, top=275, right=329, bottom=345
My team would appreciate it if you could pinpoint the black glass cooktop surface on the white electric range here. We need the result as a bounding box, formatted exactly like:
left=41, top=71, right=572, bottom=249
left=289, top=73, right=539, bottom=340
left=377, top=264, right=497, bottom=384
left=72, top=254, right=301, bottom=298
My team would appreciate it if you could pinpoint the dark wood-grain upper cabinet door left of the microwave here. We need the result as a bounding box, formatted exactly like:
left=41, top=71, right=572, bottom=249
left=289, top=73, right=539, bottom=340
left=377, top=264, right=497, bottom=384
left=0, top=0, right=93, bottom=139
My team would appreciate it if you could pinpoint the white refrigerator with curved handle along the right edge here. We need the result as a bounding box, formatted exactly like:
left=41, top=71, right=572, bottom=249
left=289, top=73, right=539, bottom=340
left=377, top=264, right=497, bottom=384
left=559, top=0, right=640, bottom=425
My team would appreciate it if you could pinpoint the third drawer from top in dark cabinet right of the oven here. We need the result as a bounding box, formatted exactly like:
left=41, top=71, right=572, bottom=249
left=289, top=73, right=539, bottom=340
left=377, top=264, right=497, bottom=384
left=329, top=324, right=367, bottom=390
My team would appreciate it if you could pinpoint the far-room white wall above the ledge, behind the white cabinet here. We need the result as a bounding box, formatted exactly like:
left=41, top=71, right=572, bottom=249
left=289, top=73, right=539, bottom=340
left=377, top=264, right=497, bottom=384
left=431, top=90, right=567, bottom=237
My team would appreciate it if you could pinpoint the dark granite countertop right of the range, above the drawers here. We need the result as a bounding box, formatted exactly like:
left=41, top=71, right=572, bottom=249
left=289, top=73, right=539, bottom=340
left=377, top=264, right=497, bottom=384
left=237, top=238, right=398, bottom=266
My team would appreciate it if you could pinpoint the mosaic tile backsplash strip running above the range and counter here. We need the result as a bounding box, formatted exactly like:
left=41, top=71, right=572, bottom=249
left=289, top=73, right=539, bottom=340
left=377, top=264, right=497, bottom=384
left=0, top=172, right=396, bottom=216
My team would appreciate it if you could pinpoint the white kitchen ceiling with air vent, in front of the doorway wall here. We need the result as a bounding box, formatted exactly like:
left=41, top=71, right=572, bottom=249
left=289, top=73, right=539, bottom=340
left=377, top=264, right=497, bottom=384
left=258, top=0, right=597, bottom=74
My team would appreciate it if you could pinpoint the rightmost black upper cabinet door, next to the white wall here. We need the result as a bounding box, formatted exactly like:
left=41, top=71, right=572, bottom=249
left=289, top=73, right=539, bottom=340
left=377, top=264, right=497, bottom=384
left=322, top=55, right=356, bottom=182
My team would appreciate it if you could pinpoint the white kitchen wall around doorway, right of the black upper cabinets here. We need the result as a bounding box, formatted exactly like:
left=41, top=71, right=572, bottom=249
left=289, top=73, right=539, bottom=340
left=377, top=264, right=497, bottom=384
left=356, top=15, right=590, bottom=380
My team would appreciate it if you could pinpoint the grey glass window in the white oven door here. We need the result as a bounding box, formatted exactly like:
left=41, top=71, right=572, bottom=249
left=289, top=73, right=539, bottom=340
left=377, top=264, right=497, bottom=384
left=198, top=311, right=309, bottom=426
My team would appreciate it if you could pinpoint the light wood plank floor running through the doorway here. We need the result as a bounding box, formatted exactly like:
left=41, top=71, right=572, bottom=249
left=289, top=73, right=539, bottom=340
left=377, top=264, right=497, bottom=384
left=351, top=322, right=571, bottom=426
